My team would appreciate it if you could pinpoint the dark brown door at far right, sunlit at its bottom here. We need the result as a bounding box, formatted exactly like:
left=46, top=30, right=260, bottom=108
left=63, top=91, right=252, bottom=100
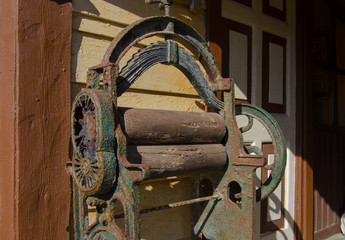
left=312, top=1, right=345, bottom=239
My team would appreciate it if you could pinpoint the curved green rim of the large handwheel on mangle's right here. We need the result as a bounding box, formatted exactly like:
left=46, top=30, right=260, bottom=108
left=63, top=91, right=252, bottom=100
left=236, top=104, right=286, bottom=201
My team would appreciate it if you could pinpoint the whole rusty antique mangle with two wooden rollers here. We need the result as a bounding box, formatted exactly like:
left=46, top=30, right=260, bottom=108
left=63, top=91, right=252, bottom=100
left=67, top=0, right=286, bottom=240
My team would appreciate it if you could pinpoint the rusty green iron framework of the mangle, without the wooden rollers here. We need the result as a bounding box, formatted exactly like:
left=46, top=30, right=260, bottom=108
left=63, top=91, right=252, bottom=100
left=67, top=0, right=286, bottom=240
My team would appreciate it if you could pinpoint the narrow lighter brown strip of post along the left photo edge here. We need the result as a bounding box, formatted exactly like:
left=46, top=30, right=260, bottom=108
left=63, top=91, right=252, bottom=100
left=0, top=1, right=19, bottom=240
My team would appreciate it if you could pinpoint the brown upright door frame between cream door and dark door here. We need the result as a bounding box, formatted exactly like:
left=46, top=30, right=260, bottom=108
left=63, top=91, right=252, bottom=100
left=294, top=0, right=314, bottom=240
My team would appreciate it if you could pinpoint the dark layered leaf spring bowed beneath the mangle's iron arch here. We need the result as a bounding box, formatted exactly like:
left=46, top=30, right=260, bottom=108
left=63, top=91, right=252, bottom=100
left=117, top=40, right=223, bottom=110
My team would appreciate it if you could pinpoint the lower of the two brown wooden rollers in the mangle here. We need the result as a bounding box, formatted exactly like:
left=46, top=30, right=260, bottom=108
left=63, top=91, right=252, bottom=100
left=127, top=144, right=227, bottom=178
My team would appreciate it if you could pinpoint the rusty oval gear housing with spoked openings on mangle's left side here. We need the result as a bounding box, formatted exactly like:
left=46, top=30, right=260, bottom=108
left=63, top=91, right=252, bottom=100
left=71, top=89, right=116, bottom=194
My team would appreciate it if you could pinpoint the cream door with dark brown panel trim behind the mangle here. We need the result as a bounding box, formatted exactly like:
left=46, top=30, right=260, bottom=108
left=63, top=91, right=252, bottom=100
left=207, top=0, right=295, bottom=239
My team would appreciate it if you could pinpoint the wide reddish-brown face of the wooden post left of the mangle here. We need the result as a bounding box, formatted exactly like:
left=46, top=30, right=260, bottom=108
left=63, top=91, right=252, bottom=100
left=16, top=0, right=73, bottom=240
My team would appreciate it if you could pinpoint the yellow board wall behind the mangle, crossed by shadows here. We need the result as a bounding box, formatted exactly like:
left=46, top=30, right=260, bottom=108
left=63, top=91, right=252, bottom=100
left=71, top=0, right=205, bottom=240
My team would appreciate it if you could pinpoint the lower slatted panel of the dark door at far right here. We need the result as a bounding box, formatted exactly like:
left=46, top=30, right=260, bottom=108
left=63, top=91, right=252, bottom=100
left=313, top=125, right=345, bottom=240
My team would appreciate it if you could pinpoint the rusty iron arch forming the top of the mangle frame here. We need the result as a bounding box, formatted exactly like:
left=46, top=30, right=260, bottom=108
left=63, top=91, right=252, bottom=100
left=102, top=16, right=222, bottom=91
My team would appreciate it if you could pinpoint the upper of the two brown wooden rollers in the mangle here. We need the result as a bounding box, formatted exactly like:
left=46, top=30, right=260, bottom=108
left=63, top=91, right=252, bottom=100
left=120, top=108, right=226, bottom=145
